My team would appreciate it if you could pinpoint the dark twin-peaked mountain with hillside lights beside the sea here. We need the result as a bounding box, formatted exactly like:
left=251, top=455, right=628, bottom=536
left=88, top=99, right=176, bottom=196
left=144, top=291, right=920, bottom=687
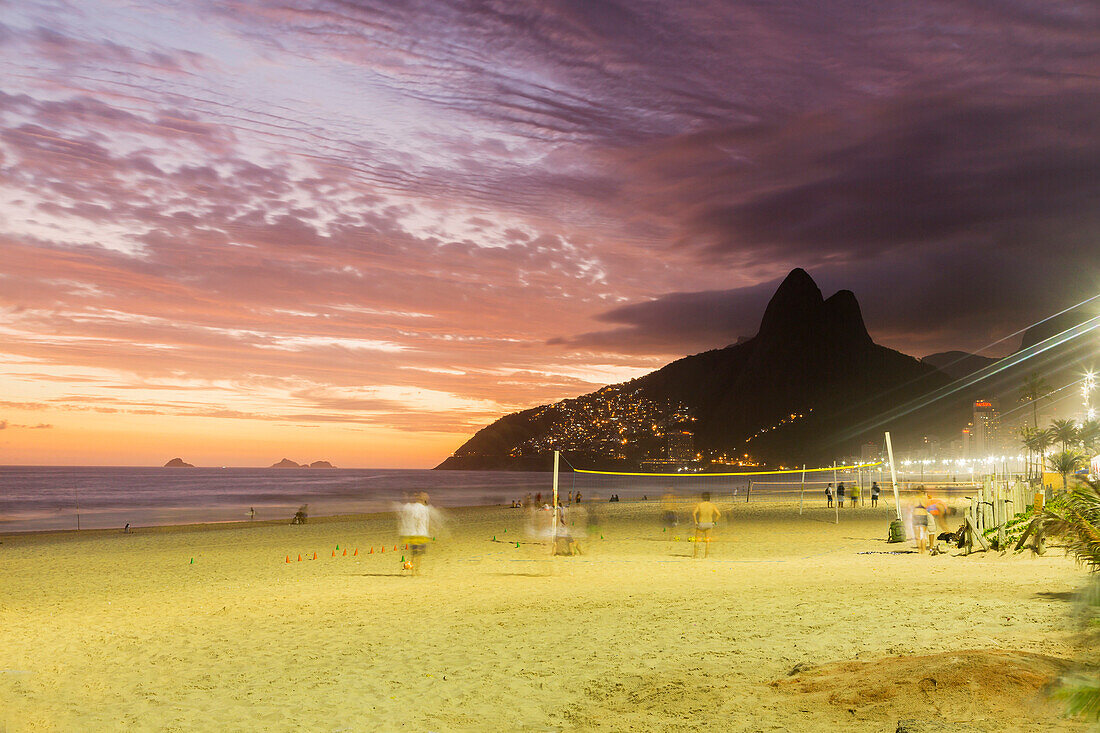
left=437, top=269, right=966, bottom=470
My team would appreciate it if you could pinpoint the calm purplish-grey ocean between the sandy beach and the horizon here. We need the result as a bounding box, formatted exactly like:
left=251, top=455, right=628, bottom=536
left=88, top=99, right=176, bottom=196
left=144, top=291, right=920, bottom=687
left=0, top=466, right=888, bottom=534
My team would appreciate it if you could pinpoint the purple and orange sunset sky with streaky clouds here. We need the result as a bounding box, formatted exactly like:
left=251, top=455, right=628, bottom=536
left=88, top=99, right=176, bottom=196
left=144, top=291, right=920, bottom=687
left=0, top=0, right=1100, bottom=468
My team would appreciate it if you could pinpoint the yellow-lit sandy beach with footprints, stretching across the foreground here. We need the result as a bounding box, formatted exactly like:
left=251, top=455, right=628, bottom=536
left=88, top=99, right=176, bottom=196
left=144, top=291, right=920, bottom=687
left=0, top=502, right=1086, bottom=733
